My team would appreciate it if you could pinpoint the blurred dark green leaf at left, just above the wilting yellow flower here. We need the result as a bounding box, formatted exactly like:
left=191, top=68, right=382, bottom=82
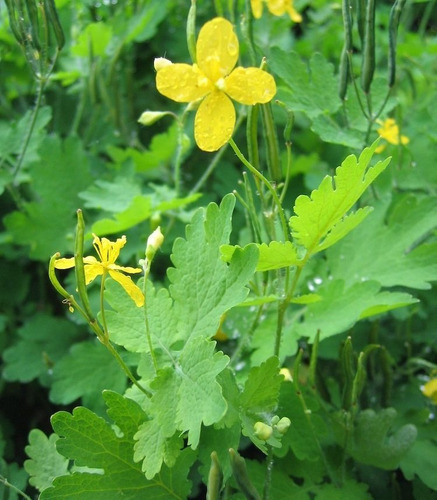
left=4, top=136, right=91, bottom=261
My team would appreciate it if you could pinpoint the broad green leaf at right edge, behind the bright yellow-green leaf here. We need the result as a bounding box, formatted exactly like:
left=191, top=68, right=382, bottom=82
left=328, top=193, right=437, bottom=289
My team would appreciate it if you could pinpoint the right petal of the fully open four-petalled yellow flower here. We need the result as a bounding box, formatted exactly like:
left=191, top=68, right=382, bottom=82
left=225, top=68, right=276, bottom=105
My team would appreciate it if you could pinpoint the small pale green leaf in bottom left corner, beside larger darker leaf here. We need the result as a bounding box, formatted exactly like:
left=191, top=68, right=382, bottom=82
left=24, top=429, right=68, bottom=491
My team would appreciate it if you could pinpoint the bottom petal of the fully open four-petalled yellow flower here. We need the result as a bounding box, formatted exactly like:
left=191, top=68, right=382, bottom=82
left=194, top=90, right=235, bottom=151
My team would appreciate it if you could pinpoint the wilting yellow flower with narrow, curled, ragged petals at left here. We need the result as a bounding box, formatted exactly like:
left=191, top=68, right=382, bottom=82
left=55, top=234, right=144, bottom=307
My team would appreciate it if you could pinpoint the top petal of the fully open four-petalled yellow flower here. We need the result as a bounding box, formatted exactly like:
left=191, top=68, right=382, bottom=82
left=196, top=17, right=239, bottom=83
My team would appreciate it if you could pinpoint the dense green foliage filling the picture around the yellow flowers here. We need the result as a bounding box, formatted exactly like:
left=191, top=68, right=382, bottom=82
left=0, top=0, right=437, bottom=500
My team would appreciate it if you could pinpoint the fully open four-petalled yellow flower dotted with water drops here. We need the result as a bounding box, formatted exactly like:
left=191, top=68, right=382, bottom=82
left=156, top=17, right=276, bottom=151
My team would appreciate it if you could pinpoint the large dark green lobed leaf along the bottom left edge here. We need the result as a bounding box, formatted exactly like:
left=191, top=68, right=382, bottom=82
left=41, top=393, right=195, bottom=500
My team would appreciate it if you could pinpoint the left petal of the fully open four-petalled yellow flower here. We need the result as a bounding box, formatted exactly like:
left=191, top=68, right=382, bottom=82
left=156, top=64, right=213, bottom=102
